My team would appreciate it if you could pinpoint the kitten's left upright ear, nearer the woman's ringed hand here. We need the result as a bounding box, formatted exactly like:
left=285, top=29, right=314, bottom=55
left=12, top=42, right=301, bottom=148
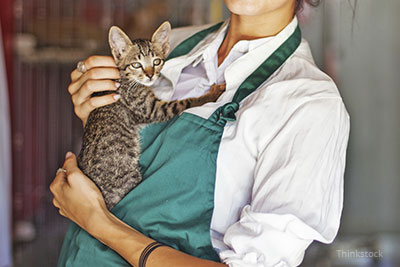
left=108, top=26, right=132, bottom=65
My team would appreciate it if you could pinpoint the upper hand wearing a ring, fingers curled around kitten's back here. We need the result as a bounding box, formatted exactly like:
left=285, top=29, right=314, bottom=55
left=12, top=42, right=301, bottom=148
left=68, top=56, right=121, bottom=126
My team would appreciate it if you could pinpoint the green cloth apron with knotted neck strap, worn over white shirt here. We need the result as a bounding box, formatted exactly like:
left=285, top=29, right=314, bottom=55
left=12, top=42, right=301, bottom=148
left=58, top=21, right=301, bottom=267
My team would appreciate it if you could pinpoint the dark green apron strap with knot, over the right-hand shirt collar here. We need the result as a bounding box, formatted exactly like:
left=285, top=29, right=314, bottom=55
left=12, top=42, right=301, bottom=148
left=209, top=26, right=301, bottom=126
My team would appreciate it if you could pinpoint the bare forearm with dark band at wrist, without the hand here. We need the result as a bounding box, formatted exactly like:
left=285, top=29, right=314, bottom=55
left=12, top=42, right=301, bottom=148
left=91, top=211, right=226, bottom=267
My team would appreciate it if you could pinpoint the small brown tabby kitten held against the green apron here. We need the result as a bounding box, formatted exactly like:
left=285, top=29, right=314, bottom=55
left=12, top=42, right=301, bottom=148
left=78, top=22, right=225, bottom=210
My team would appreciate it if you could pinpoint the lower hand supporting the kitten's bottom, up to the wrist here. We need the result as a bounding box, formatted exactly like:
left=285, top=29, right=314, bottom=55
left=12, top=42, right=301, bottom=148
left=50, top=152, right=108, bottom=230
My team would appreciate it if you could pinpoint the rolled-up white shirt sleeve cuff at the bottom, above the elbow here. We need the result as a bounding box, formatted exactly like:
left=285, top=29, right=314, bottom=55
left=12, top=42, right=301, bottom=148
left=219, top=206, right=337, bottom=267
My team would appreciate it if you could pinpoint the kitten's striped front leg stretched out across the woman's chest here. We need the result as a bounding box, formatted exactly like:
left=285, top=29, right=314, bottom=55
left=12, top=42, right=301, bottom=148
left=147, top=84, right=225, bottom=122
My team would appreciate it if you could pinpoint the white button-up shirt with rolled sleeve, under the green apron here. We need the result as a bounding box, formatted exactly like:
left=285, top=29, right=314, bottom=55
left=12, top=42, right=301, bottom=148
left=155, top=18, right=350, bottom=267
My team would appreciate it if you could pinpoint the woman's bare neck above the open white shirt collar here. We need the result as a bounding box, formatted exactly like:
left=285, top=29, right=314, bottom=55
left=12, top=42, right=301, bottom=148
left=218, top=6, right=294, bottom=66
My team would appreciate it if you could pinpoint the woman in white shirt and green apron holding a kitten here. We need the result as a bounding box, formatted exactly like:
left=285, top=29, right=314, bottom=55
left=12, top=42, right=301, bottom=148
left=51, top=0, right=349, bottom=267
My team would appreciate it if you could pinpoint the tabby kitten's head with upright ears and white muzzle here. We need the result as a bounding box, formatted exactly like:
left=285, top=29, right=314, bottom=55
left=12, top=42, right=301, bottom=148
left=108, top=21, right=171, bottom=86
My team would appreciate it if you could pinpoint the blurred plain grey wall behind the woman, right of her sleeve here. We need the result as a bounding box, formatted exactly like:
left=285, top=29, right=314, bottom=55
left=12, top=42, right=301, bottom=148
left=303, top=0, right=400, bottom=235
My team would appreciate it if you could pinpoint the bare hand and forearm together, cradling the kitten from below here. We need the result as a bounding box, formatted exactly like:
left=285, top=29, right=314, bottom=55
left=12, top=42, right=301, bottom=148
left=50, top=152, right=226, bottom=267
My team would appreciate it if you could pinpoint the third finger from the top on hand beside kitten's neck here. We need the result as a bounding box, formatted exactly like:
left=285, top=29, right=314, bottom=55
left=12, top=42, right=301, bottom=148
left=72, top=80, right=120, bottom=105
